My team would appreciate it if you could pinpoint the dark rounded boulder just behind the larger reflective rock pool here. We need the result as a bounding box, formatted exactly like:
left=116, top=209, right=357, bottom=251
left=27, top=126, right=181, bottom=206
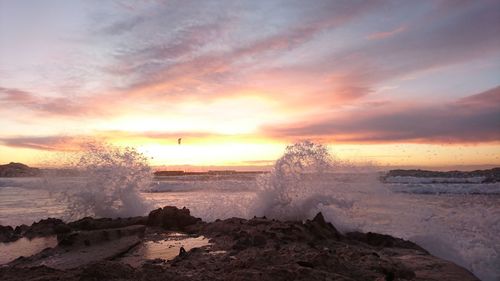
left=147, top=206, right=201, bottom=230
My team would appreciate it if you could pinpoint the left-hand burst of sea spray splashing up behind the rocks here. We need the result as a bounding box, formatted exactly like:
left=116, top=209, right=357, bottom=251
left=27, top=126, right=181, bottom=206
left=52, top=142, right=152, bottom=219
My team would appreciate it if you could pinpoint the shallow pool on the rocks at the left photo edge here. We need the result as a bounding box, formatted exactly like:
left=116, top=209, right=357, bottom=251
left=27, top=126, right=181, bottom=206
left=0, top=236, right=57, bottom=264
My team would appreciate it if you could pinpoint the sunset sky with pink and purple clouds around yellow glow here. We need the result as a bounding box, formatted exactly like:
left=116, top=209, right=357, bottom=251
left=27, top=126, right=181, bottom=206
left=0, top=0, right=500, bottom=167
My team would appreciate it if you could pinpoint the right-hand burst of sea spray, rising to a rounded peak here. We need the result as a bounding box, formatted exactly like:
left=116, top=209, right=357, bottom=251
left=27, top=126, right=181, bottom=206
left=253, top=141, right=358, bottom=220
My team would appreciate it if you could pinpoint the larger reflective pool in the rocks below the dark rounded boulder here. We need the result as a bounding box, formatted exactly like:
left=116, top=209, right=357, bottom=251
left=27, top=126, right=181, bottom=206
left=119, top=233, right=210, bottom=267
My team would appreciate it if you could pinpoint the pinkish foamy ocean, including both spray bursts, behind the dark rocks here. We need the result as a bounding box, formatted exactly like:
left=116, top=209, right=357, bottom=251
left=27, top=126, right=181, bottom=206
left=0, top=142, right=500, bottom=281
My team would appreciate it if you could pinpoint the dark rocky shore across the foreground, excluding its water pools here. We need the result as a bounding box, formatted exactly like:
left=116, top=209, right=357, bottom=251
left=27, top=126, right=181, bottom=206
left=0, top=207, right=478, bottom=281
